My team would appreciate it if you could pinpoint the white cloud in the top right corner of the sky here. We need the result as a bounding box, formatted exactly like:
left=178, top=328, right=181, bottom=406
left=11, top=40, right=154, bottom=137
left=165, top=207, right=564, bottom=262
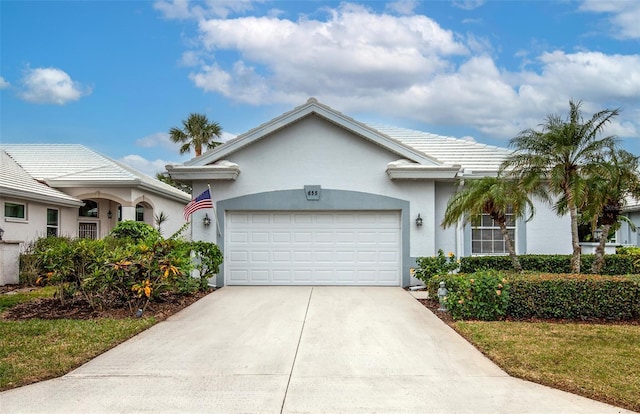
left=580, top=0, right=640, bottom=39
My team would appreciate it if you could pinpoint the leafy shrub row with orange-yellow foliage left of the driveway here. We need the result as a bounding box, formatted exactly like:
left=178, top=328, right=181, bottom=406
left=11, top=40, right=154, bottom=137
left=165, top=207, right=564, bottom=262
left=22, top=222, right=222, bottom=310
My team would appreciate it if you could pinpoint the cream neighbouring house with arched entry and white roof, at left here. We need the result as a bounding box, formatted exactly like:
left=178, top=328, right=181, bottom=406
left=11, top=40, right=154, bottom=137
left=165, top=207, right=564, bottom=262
left=0, top=144, right=191, bottom=241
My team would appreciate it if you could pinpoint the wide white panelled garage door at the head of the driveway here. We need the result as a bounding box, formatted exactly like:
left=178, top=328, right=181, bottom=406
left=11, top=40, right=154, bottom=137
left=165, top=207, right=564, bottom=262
left=224, top=211, right=401, bottom=286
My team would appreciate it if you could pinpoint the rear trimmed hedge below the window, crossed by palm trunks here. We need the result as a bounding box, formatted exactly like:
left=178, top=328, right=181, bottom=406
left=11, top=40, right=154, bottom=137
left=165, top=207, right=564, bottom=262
left=460, top=254, right=636, bottom=275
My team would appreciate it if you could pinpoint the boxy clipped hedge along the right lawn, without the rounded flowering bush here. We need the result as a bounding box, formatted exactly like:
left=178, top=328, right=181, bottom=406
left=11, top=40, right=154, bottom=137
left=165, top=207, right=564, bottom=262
left=507, top=274, right=640, bottom=320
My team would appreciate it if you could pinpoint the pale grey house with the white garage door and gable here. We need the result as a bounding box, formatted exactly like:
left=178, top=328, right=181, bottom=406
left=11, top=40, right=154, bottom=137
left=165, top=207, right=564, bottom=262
left=167, top=98, right=571, bottom=286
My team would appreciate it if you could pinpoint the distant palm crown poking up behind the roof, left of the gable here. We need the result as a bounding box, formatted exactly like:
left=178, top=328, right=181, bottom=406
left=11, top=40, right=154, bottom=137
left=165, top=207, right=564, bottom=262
left=169, top=114, right=222, bottom=157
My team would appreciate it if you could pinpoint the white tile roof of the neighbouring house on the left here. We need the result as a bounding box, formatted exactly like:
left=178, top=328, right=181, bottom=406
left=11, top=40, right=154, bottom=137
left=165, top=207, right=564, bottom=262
left=0, top=144, right=191, bottom=202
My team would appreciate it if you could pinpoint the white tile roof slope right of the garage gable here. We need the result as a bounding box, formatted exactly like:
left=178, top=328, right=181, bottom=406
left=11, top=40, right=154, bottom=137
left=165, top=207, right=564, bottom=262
left=368, top=124, right=511, bottom=173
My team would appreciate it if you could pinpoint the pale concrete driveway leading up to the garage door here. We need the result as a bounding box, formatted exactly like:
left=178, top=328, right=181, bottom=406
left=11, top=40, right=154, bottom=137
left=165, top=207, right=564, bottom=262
left=0, top=287, right=628, bottom=413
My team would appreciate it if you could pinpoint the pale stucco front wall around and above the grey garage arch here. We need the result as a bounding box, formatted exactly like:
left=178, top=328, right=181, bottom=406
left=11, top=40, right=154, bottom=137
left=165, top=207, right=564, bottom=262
left=193, top=116, right=441, bottom=257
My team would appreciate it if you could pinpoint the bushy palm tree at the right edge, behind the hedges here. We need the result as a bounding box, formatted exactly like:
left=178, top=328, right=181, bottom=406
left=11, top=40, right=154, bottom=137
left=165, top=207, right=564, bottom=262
left=581, top=150, right=640, bottom=273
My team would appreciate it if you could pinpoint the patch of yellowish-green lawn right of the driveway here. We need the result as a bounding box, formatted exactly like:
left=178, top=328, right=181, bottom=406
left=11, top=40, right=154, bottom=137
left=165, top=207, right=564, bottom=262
left=454, top=321, right=640, bottom=411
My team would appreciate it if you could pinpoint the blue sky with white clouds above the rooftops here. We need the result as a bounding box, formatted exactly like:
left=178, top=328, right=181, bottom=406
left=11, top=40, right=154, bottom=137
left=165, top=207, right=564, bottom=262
left=0, top=0, right=640, bottom=175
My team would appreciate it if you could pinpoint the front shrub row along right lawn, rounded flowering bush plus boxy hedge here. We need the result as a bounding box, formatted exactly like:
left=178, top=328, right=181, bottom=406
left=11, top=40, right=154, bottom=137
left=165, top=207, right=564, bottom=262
left=427, top=271, right=640, bottom=320
